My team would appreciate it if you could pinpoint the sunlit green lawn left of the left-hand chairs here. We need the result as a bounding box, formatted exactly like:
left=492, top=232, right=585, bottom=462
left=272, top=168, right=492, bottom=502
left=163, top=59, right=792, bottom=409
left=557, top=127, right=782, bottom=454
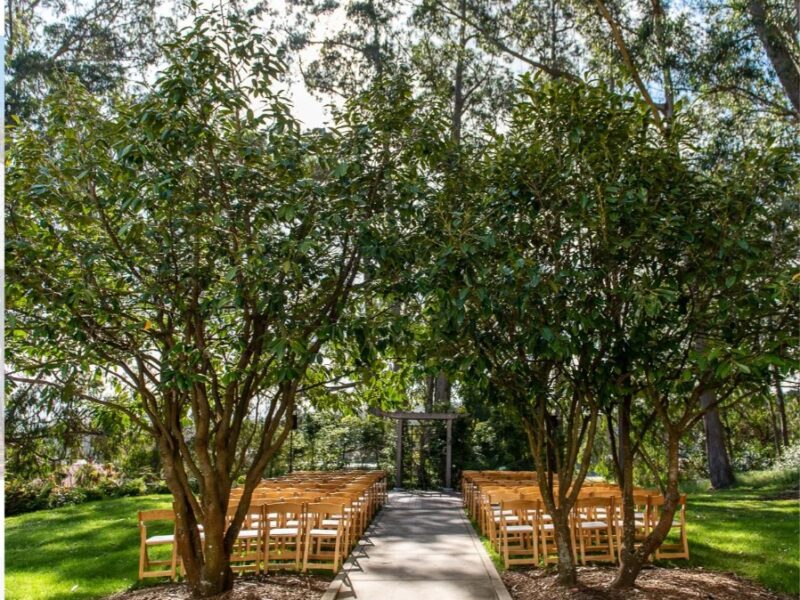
left=5, top=495, right=172, bottom=600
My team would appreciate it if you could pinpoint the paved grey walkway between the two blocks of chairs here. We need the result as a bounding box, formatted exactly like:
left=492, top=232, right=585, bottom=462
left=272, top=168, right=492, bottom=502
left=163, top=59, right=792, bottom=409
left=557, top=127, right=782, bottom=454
left=337, top=492, right=510, bottom=600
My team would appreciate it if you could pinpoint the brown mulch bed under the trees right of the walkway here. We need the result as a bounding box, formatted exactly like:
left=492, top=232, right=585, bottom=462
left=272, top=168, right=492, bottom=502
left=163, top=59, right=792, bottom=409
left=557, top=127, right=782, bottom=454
left=501, top=567, right=790, bottom=600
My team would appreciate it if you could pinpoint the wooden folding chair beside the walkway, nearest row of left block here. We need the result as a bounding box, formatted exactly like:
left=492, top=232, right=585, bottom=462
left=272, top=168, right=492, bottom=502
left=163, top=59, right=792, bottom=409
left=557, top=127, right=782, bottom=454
left=303, top=502, right=345, bottom=573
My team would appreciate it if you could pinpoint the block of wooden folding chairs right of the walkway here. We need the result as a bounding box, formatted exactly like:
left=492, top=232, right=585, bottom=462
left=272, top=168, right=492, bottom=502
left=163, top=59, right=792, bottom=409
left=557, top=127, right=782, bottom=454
left=462, top=471, right=689, bottom=566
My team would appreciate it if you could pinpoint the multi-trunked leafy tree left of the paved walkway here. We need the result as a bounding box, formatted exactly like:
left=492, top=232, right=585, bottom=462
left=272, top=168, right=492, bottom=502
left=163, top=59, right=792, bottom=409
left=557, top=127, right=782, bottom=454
left=6, top=11, right=439, bottom=597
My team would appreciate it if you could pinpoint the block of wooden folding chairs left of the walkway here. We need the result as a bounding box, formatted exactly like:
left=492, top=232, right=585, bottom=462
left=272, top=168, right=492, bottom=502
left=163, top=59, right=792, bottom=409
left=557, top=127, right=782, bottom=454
left=138, top=471, right=387, bottom=579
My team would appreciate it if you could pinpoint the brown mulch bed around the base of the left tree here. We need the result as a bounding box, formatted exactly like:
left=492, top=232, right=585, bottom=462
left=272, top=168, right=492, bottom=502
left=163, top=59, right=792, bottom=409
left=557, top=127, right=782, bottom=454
left=106, top=574, right=332, bottom=600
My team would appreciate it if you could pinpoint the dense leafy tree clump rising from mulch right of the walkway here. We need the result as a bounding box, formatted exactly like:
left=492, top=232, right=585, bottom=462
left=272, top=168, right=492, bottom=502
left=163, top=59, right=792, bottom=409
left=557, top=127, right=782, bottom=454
left=431, top=75, right=797, bottom=587
